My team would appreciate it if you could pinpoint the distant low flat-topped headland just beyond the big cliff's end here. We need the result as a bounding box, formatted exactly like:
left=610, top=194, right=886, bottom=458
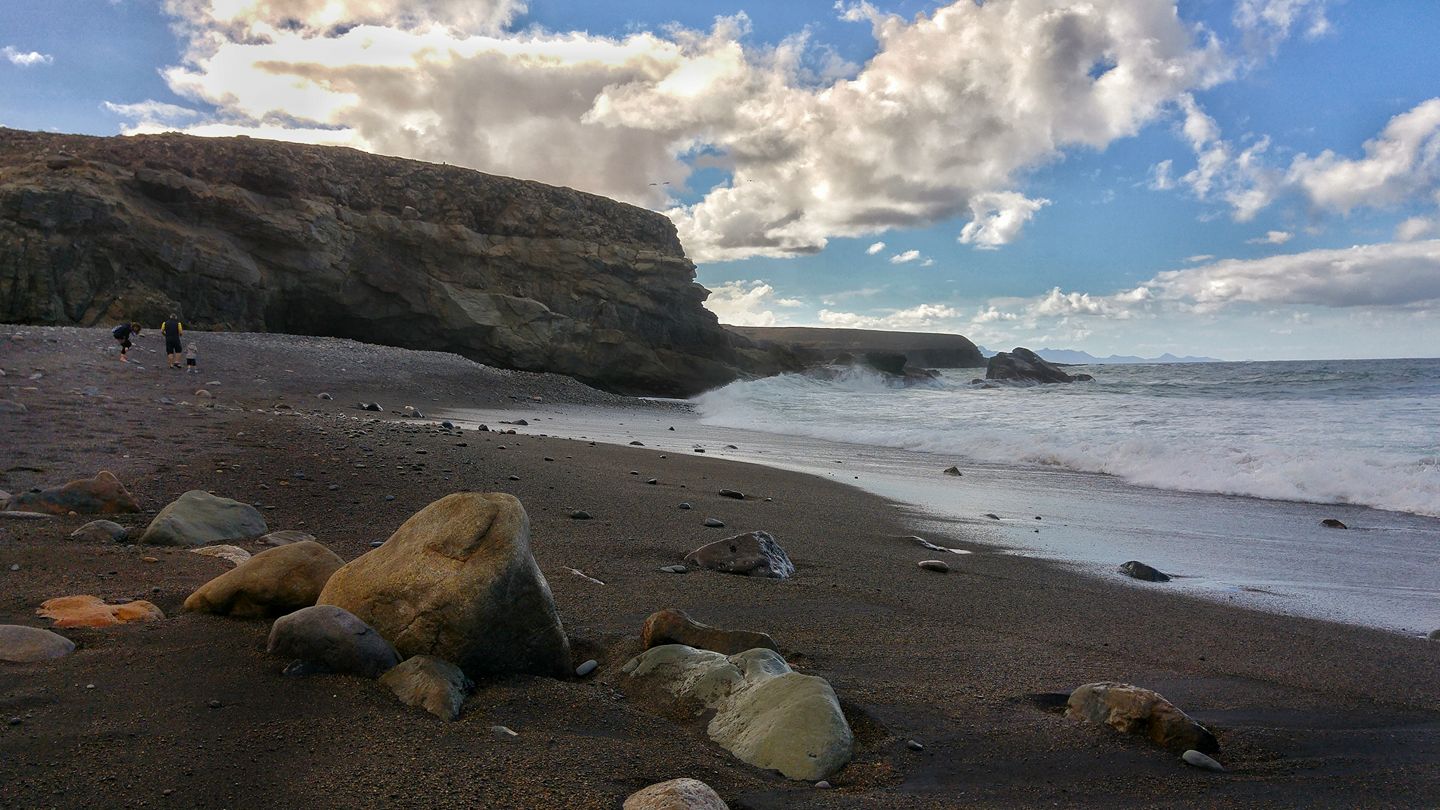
left=726, top=326, right=985, bottom=369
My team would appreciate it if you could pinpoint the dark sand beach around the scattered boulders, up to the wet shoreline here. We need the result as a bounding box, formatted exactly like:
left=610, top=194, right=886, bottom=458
left=0, top=327, right=1440, bottom=809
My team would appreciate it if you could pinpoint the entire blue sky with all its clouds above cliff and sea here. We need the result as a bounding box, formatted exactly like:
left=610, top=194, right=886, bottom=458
left=0, top=0, right=1440, bottom=359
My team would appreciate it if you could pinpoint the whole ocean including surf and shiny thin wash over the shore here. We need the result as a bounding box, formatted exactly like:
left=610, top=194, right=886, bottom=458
left=445, top=360, right=1440, bottom=636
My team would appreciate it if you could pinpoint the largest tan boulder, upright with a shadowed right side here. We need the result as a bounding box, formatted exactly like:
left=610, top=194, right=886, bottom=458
left=321, top=493, right=570, bottom=677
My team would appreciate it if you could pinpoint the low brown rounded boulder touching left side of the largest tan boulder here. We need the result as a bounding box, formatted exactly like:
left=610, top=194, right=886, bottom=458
left=184, top=540, right=344, bottom=618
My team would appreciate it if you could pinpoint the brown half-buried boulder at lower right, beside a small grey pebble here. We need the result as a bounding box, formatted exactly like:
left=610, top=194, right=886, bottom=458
left=1066, top=682, right=1220, bottom=754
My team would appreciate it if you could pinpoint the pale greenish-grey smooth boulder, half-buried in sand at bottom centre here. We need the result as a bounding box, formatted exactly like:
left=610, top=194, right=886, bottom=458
left=622, top=644, right=854, bottom=781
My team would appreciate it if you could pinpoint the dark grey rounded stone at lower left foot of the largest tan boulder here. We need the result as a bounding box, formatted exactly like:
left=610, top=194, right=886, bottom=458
left=264, top=605, right=400, bottom=677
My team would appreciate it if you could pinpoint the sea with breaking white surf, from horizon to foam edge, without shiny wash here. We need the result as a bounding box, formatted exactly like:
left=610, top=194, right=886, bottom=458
left=697, top=360, right=1440, bottom=516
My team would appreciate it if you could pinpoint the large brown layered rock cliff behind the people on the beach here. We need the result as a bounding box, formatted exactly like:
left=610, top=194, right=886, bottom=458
left=0, top=128, right=765, bottom=395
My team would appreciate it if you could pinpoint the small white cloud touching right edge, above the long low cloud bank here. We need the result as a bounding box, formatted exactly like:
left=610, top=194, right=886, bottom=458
left=1287, top=98, right=1440, bottom=213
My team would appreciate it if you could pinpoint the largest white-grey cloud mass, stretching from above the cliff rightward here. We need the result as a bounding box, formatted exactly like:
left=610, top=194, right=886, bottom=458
left=151, top=0, right=1231, bottom=261
